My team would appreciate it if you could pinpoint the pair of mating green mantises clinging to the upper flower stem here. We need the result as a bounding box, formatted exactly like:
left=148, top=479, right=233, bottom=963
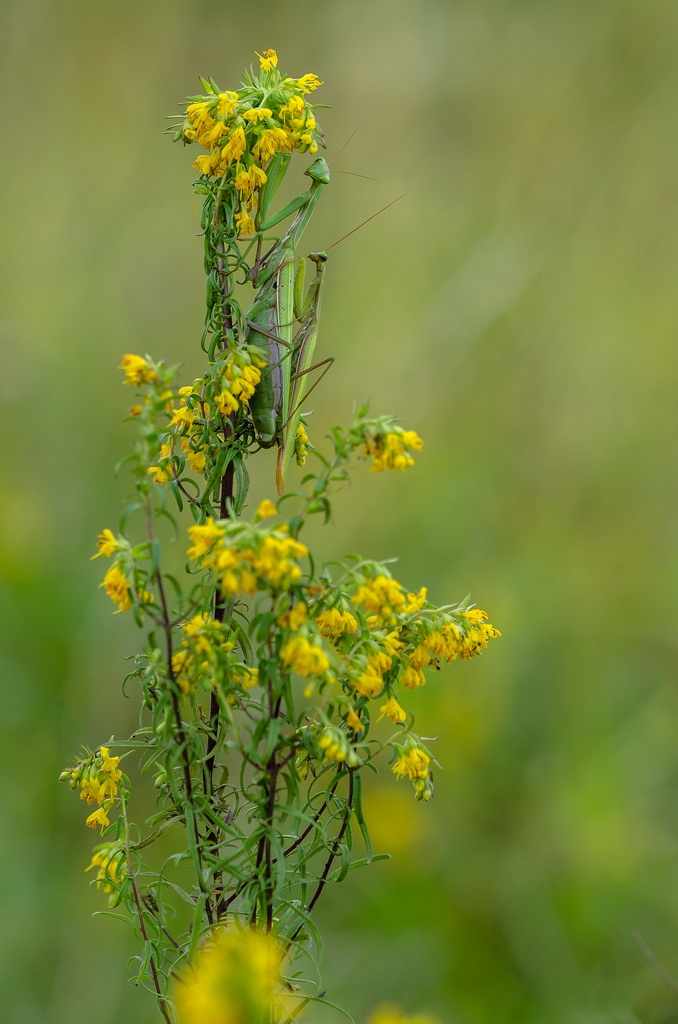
left=247, top=158, right=332, bottom=494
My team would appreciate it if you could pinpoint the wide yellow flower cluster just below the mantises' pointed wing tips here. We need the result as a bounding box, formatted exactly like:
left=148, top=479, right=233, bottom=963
left=188, top=518, right=308, bottom=594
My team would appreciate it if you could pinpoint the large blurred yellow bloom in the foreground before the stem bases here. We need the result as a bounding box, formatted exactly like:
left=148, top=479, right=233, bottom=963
left=173, top=928, right=283, bottom=1024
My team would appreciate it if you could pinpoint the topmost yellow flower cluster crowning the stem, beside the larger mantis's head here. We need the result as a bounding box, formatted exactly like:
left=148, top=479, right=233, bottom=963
left=176, top=50, right=322, bottom=237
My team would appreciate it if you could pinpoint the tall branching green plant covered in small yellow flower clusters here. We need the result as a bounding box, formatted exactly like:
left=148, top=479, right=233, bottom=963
left=61, top=50, right=499, bottom=1024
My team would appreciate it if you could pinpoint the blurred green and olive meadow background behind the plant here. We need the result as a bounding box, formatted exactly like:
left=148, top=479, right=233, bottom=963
left=0, top=0, right=678, bottom=1024
